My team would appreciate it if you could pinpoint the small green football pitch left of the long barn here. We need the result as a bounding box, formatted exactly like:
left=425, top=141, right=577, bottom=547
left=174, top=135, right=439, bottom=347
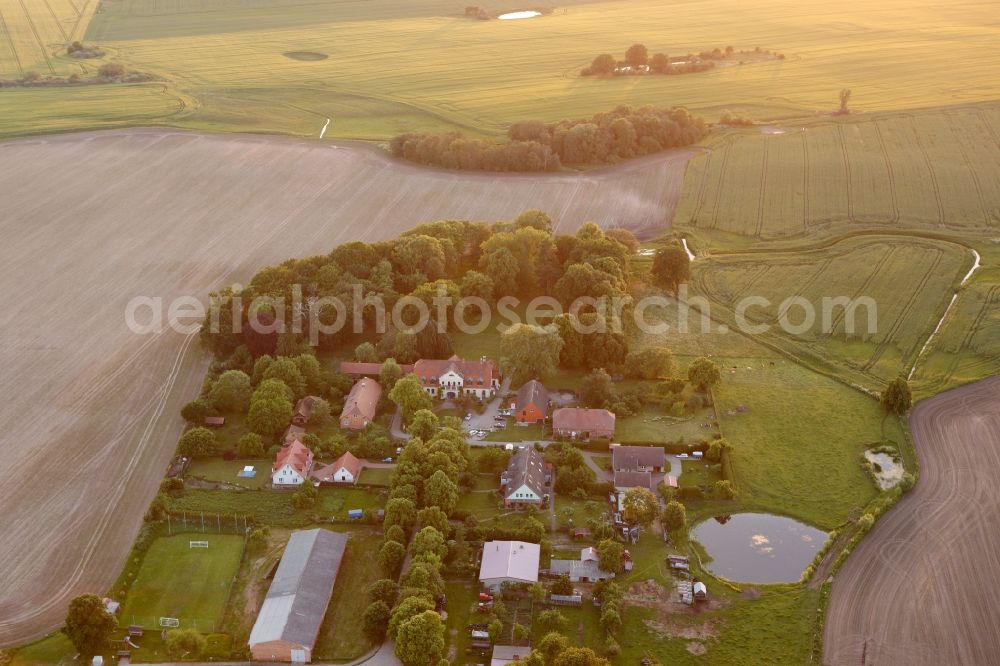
left=121, top=534, right=243, bottom=632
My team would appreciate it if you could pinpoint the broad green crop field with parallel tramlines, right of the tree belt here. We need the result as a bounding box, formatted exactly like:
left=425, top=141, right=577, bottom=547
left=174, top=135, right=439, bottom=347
left=675, top=109, right=1000, bottom=238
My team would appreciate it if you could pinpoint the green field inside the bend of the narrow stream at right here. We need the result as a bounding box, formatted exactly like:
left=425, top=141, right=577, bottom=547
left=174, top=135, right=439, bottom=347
left=694, top=236, right=972, bottom=386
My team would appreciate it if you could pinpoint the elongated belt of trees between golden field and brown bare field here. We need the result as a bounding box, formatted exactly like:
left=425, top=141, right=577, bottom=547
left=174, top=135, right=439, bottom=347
left=389, top=106, right=708, bottom=171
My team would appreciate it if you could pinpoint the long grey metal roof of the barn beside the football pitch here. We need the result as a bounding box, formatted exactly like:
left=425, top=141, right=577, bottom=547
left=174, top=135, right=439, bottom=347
left=248, top=529, right=347, bottom=647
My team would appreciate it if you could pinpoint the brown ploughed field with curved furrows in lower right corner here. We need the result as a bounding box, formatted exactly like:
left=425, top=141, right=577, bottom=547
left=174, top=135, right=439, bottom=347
left=824, top=377, right=1000, bottom=666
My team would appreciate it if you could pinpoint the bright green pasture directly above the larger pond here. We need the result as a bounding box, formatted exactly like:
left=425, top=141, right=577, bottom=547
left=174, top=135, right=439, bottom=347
left=716, top=359, right=904, bottom=530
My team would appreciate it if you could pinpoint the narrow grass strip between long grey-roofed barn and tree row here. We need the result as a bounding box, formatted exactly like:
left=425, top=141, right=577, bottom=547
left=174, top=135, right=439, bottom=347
left=315, top=530, right=382, bottom=661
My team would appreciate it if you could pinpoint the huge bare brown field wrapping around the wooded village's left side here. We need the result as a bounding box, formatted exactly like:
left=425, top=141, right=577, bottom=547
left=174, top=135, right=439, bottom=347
left=0, top=130, right=689, bottom=646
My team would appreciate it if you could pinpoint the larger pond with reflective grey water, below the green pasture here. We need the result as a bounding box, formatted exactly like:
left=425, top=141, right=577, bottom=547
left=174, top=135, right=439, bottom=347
left=692, top=513, right=827, bottom=583
